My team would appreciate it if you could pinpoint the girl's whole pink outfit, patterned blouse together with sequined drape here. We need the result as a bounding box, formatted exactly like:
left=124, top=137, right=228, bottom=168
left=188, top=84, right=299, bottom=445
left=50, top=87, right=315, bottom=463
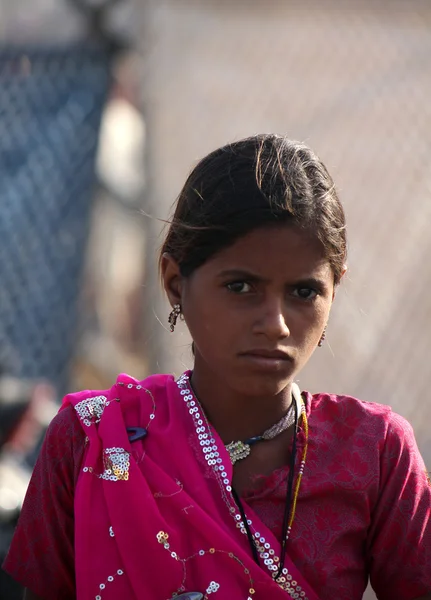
left=5, top=375, right=431, bottom=600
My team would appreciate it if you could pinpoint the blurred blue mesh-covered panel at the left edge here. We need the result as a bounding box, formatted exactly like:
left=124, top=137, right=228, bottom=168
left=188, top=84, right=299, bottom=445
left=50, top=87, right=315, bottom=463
left=0, top=46, right=110, bottom=386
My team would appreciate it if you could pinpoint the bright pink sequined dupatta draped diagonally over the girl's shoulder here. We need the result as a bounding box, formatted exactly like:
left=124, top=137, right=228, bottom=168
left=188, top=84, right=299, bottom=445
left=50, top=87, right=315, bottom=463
left=63, top=374, right=318, bottom=600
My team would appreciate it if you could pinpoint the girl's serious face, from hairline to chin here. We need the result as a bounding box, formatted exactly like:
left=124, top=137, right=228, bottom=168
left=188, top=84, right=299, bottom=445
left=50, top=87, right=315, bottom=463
left=163, top=225, right=340, bottom=396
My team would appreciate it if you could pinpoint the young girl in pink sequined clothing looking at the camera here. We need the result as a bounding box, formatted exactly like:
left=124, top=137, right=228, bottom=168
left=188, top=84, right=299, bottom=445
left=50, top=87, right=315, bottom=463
left=5, top=135, right=431, bottom=600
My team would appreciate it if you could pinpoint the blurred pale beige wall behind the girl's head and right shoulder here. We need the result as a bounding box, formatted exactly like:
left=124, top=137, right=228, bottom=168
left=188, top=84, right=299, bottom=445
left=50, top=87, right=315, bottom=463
left=139, top=0, right=431, bottom=454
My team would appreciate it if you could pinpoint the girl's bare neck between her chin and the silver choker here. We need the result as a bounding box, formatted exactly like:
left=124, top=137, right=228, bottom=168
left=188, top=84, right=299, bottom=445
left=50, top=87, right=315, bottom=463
left=191, top=361, right=292, bottom=444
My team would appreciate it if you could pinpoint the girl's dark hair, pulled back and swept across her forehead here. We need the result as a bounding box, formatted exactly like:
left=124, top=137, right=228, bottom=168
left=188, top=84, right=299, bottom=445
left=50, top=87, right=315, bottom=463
left=161, top=134, right=347, bottom=283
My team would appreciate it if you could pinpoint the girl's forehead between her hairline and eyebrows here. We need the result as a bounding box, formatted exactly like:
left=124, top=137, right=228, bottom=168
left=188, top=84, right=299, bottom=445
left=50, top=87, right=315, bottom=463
left=206, top=225, right=333, bottom=278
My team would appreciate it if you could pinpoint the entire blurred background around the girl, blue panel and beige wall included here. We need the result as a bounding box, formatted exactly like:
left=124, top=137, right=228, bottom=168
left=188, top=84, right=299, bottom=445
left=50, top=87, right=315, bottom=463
left=0, top=0, right=431, bottom=600
